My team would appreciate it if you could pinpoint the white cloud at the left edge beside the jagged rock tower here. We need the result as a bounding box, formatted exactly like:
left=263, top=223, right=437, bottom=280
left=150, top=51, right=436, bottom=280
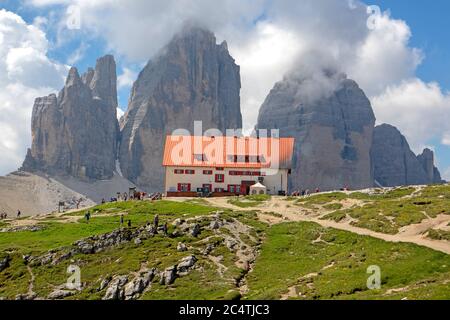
left=0, top=10, right=67, bottom=174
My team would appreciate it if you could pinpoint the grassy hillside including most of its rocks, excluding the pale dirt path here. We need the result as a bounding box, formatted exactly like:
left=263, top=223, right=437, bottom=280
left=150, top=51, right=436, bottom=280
left=0, top=189, right=450, bottom=299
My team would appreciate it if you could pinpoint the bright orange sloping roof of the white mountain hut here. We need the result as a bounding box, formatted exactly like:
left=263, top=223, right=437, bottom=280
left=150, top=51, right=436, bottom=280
left=163, top=135, right=294, bottom=169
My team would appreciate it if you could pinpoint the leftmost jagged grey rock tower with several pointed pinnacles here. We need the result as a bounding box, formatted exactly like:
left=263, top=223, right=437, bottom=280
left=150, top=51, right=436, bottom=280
left=22, top=55, right=119, bottom=179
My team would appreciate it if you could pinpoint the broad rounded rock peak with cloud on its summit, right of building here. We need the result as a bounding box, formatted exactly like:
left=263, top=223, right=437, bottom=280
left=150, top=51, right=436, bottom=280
left=257, top=71, right=375, bottom=190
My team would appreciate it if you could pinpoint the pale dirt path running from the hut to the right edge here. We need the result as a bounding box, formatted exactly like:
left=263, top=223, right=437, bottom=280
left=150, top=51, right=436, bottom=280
left=207, top=197, right=450, bottom=254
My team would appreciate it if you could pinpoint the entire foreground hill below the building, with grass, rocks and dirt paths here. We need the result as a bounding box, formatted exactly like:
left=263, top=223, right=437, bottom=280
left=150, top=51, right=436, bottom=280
left=0, top=185, right=450, bottom=299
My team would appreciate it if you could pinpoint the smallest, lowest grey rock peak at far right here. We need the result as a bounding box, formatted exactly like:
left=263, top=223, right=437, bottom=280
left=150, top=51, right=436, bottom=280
left=371, top=124, right=442, bottom=187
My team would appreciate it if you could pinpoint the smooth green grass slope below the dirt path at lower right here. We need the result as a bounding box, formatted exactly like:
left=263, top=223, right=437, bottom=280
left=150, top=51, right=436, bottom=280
left=246, top=222, right=450, bottom=299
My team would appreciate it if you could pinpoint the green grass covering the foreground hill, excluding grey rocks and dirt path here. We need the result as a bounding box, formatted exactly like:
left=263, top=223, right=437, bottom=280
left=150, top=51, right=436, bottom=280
left=0, top=195, right=450, bottom=300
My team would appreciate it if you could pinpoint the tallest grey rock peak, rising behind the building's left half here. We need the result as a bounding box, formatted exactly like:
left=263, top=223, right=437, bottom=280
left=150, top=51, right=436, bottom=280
left=119, top=27, right=242, bottom=191
